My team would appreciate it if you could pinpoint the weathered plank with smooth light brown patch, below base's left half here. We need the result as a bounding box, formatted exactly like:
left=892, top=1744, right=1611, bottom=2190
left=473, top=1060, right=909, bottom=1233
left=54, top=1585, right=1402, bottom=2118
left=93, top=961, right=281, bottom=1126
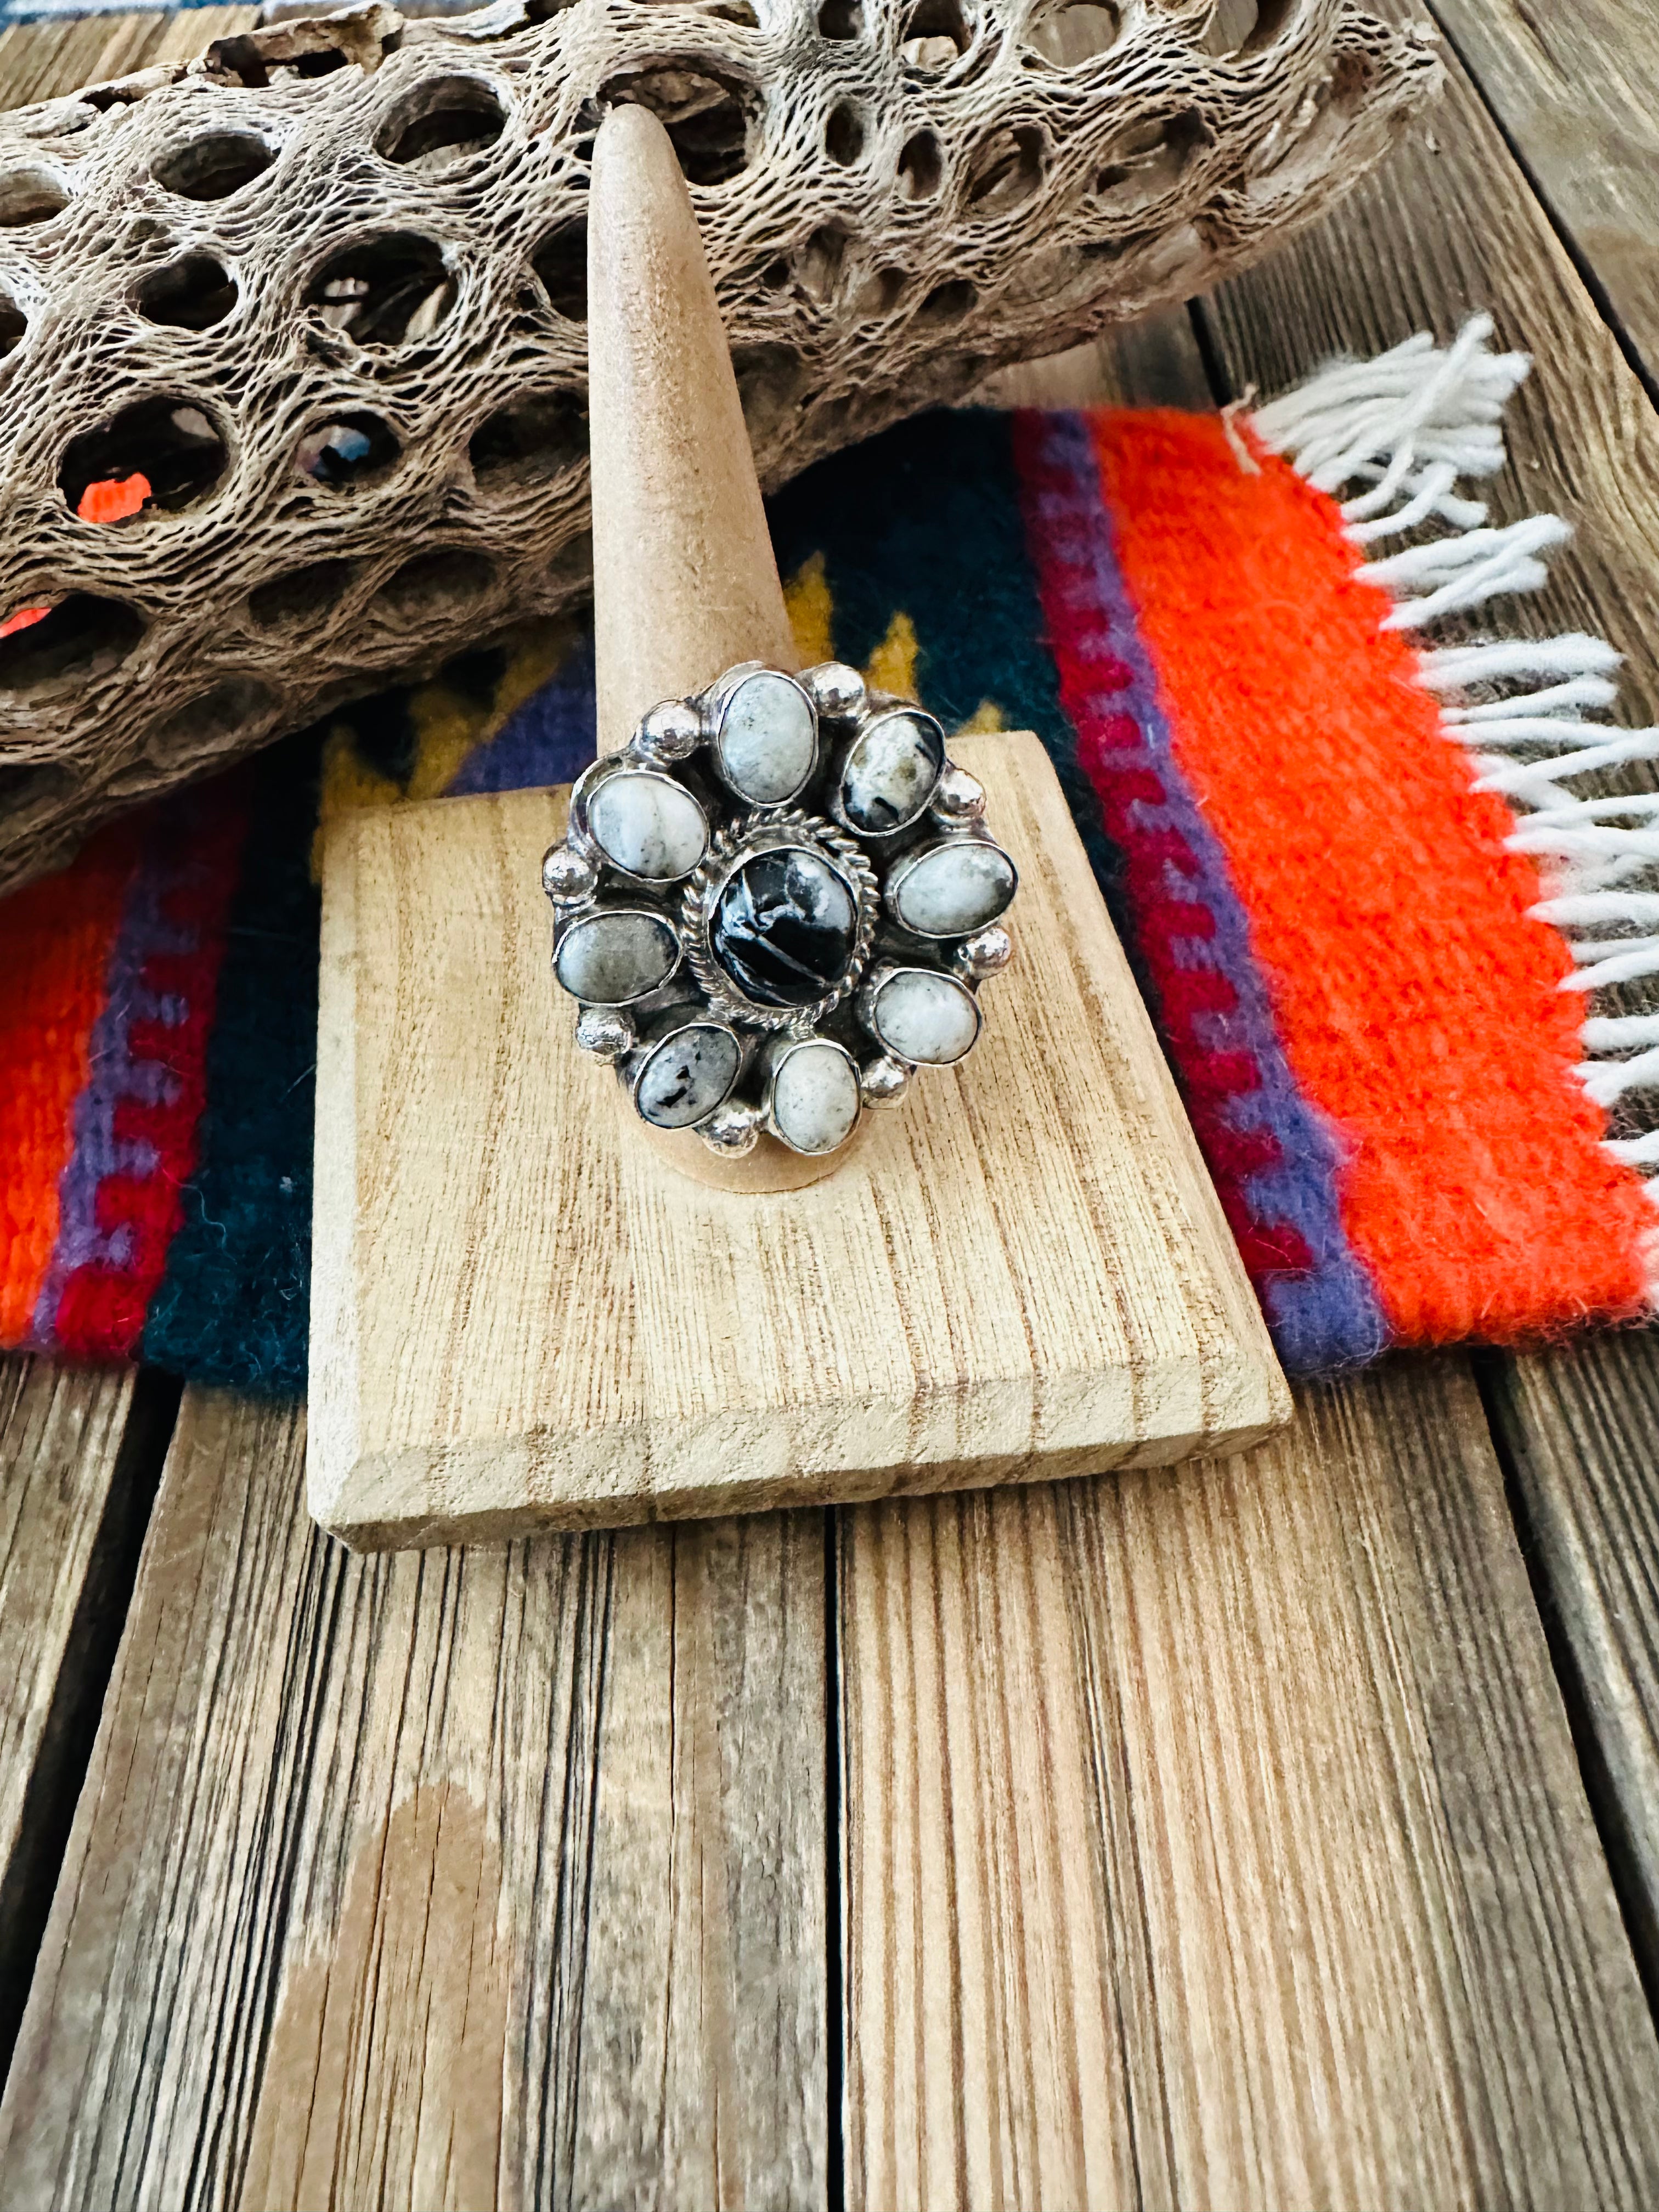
left=0, top=1391, right=827, bottom=2212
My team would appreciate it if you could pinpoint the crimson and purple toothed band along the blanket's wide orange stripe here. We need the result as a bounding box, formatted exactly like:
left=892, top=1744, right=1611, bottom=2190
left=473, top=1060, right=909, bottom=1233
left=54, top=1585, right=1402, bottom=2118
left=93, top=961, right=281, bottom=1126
left=1020, top=414, right=1387, bottom=1374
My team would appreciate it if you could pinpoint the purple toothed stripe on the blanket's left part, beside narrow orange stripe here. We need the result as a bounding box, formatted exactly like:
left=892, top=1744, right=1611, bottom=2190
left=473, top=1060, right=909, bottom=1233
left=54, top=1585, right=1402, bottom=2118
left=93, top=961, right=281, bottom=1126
left=33, top=814, right=197, bottom=1352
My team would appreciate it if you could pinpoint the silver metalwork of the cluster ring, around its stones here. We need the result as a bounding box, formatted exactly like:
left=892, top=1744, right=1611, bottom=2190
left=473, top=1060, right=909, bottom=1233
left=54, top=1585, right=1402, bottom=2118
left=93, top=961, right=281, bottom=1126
left=542, top=662, right=1018, bottom=1159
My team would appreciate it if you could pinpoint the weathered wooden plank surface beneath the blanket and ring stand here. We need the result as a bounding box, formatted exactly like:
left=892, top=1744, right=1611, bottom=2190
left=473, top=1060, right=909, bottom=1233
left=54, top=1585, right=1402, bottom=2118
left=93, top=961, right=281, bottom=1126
left=0, top=0, right=1659, bottom=2212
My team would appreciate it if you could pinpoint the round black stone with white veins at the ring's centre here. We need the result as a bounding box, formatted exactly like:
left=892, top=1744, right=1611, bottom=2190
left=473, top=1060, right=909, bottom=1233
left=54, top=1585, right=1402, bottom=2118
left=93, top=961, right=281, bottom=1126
left=708, top=845, right=858, bottom=1007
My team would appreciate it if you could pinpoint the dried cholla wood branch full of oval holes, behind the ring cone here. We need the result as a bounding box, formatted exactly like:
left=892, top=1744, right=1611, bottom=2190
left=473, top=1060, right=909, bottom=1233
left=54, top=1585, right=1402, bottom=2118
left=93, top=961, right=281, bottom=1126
left=0, top=0, right=1436, bottom=885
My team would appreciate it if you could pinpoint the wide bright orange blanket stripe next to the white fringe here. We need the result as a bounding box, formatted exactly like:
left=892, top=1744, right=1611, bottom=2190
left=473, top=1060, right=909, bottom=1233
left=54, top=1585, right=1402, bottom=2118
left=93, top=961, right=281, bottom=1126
left=1095, top=414, right=1652, bottom=1342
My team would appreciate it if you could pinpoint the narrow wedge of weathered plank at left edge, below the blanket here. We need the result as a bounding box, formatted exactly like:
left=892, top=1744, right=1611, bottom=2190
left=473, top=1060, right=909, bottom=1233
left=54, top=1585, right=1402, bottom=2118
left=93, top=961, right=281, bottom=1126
left=0, top=1358, right=175, bottom=2073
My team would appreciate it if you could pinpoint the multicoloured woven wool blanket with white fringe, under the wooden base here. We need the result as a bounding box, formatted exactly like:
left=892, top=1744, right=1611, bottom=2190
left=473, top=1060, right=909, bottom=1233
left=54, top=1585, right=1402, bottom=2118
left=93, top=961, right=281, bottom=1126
left=0, top=321, right=1659, bottom=1391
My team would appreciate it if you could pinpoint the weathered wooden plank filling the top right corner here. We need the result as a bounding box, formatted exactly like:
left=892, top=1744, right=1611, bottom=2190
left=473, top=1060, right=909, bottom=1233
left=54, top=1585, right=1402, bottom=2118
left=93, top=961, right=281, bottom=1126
left=1429, top=0, right=1659, bottom=390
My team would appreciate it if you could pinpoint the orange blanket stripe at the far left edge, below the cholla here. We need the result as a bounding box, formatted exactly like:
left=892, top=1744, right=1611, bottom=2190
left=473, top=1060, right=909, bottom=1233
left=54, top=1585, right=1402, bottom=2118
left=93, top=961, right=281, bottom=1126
left=0, top=827, right=137, bottom=1345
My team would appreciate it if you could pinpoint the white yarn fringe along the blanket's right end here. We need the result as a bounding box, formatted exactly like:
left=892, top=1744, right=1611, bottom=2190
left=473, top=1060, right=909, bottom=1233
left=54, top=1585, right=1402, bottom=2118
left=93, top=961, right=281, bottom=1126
left=1254, top=314, right=1659, bottom=1190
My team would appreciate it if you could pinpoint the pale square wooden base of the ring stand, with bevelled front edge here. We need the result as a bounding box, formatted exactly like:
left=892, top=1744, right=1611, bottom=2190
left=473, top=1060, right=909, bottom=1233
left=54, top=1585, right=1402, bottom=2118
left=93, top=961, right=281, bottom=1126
left=309, top=735, right=1290, bottom=1548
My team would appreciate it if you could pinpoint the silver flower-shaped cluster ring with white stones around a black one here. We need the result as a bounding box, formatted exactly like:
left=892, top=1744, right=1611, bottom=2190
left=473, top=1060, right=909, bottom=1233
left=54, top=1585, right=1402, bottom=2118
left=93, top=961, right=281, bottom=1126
left=542, top=662, right=1018, bottom=1153
